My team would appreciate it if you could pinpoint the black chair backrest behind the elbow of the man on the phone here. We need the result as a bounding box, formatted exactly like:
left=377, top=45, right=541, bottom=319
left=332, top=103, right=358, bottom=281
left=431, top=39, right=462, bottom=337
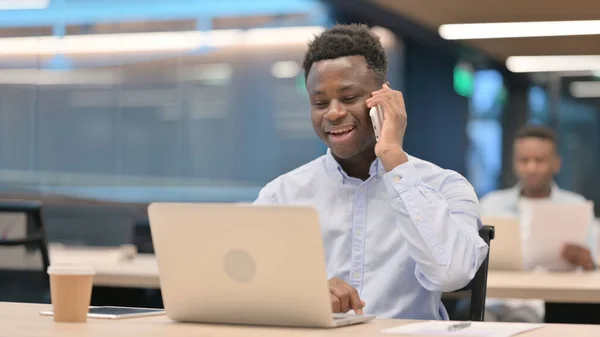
left=456, top=225, right=495, bottom=321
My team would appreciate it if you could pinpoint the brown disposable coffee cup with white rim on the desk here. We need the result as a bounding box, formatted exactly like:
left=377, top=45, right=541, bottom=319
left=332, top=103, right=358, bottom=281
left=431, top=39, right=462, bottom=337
left=48, top=264, right=95, bottom=323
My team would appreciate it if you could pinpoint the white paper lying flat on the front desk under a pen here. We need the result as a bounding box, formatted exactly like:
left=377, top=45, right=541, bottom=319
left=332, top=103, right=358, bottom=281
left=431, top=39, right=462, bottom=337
left=381, top=321, right=543, bottom=337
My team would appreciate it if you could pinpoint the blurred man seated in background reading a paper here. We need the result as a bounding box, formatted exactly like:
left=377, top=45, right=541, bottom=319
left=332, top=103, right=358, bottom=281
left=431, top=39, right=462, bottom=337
left=481, top=125, right=597, bottom=322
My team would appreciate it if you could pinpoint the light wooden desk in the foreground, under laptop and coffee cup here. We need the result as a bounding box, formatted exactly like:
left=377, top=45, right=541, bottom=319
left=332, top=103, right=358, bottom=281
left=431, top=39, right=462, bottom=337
left=0, top=303, right=600, bottom=337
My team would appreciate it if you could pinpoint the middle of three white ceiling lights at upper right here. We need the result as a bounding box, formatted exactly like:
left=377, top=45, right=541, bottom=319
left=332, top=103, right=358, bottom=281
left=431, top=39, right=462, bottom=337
left=506, top=55, right=600, bottom=73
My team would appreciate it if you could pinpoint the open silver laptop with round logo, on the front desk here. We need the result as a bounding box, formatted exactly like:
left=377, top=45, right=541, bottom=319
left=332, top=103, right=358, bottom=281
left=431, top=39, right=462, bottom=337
left=148, top=203, right=374, bottom=328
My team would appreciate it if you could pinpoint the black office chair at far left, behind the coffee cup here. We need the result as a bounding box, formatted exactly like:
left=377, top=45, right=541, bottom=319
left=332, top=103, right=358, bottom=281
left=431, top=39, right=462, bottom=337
left=0, top=200, right=50, bottom=302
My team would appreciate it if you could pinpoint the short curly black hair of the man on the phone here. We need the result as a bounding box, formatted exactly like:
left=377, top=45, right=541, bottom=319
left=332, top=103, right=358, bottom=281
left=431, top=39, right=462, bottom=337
left=302, top=24, right=387, bottom=83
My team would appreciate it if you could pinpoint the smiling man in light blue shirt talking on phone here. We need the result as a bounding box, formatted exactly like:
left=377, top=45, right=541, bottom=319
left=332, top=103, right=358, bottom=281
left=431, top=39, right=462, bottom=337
left=255, top=25, right=488, bottom=319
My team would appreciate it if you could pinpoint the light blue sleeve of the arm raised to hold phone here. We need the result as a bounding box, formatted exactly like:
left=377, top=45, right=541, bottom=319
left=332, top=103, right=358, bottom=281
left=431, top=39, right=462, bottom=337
left=384, top=161, right=488, bottom=292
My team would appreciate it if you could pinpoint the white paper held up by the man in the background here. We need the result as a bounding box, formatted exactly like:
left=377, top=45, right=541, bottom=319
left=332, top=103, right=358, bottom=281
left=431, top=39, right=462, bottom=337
left=519, top=201, right=594, bottom=271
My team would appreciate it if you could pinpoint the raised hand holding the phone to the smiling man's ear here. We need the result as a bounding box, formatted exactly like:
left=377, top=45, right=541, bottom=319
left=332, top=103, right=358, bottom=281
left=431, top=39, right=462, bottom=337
left=366, top=83, right=408, bottom=172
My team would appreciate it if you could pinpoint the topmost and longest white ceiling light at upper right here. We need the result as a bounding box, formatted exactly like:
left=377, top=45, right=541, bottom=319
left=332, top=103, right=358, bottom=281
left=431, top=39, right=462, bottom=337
left=438, top=20, right=600, bottom=40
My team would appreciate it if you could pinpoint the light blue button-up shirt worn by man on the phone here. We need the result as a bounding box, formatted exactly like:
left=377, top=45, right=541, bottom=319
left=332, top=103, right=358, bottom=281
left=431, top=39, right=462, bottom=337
left=256, top=151, right=488, bottom=319
